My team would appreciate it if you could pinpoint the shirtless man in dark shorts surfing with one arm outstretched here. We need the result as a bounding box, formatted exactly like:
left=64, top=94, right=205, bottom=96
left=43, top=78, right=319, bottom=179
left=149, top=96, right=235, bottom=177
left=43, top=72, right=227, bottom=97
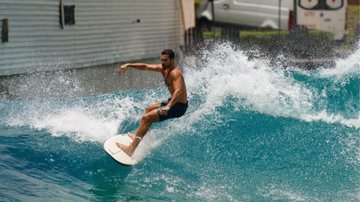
left=116, top=49, right=188, bottom=156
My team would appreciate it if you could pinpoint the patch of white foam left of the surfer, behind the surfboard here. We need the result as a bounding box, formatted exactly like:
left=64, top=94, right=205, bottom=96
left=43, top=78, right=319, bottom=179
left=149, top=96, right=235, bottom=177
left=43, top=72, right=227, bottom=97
left=8, top=97, right=141, bottom=142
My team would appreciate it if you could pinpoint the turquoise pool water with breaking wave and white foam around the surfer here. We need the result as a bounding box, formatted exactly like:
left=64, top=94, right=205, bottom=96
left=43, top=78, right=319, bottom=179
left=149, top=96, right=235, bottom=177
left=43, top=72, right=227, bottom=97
left=0, top=44, right=360, bottom=201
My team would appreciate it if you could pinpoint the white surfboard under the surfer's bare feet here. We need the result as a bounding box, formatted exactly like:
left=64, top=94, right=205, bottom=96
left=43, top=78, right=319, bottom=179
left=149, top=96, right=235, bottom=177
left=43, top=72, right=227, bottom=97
left=104, top=134, right=137, bottom=166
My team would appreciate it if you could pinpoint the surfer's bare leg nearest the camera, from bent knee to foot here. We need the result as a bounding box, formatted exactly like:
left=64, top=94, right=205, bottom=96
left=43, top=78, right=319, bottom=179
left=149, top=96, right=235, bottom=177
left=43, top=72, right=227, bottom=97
left=116, top=110, right=159, bottom=156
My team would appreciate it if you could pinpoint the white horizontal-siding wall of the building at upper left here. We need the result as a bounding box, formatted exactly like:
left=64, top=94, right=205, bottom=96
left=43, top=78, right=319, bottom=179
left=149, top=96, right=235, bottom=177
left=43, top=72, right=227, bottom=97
left=0, top=0, right=183, bottom=75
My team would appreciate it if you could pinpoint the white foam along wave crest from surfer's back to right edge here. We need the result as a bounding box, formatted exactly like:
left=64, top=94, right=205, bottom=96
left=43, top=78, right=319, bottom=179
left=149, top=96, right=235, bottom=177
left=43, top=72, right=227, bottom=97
left=185, top=44, right=360, bottom=127
